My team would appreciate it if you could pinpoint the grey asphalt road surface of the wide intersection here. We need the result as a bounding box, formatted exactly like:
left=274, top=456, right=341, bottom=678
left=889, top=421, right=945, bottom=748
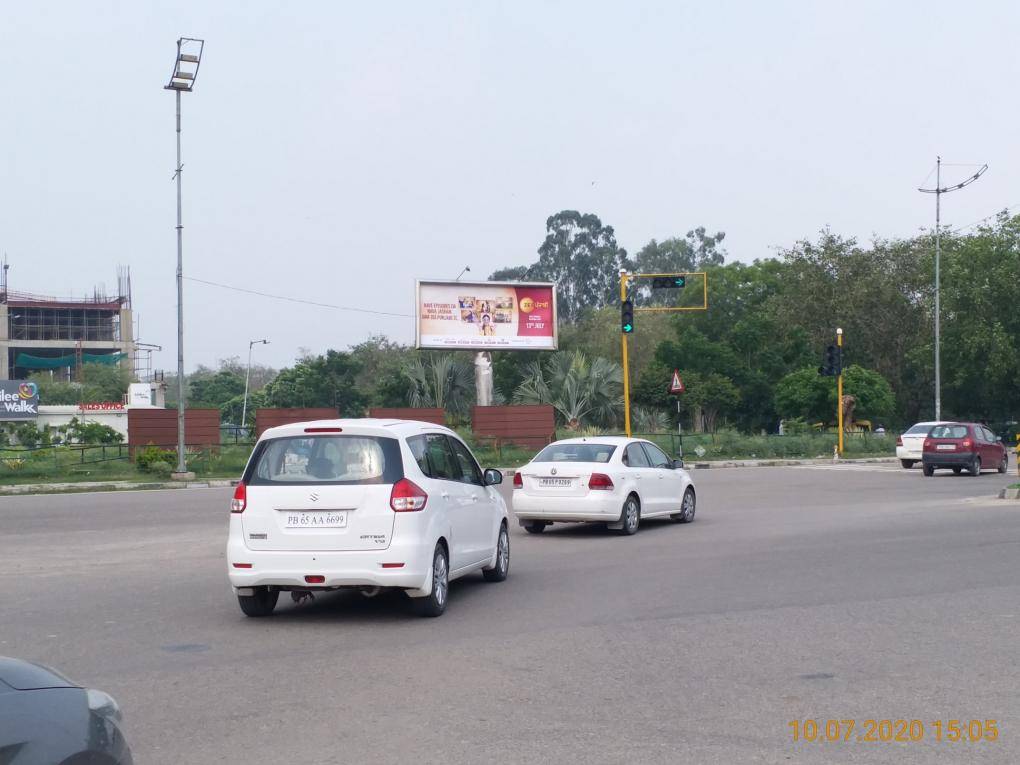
left=0, top=465, right=1020, bottom=765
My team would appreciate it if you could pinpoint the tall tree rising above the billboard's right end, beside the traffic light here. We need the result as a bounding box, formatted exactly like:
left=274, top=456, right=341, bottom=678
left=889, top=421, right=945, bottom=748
left=490, top=210, right=627, bottom=322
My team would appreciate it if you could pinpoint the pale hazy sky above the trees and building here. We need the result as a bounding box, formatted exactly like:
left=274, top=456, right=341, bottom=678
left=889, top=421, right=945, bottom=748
left=0, top=0, right=1020, bottom=370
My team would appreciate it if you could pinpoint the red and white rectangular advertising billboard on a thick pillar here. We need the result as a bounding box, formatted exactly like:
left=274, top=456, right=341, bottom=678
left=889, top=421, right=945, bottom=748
left=414, top=281, right=557, bottom=351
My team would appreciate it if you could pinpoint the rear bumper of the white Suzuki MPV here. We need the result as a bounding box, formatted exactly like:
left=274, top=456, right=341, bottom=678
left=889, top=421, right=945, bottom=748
left=226, top=534, right=435, bottom=590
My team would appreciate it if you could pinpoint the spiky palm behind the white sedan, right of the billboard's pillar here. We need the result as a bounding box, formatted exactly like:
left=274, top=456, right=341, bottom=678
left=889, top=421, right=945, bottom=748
left=513, top=351, right=623, bottom=430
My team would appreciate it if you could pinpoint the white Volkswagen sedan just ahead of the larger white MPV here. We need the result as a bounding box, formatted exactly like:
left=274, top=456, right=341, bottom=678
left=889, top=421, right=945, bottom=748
left=513, top=437, right=697, bottom=534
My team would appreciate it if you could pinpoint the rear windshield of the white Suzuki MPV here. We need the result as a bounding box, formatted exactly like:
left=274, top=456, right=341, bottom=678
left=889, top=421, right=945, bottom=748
left=245, top=436, right=404, bottom=486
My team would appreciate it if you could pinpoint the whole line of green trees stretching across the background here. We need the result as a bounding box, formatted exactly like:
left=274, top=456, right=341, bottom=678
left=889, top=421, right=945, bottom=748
left=147, top=210, right=1020, bottom=431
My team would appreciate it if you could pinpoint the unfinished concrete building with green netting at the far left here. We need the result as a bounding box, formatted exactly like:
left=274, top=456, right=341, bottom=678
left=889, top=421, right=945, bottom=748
left=0, top=262, right=138, bottom=379
